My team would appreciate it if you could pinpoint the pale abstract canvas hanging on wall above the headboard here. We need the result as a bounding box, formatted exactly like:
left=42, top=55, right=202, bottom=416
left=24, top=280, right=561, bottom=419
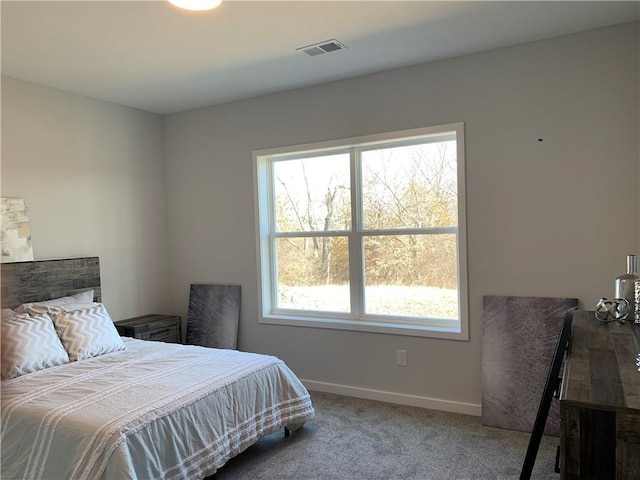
left=0, top=197, right=33, bottom=263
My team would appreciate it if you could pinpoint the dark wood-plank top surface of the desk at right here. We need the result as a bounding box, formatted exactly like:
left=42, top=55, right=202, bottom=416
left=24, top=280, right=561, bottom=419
left=560, top=311, right=640, bottom=415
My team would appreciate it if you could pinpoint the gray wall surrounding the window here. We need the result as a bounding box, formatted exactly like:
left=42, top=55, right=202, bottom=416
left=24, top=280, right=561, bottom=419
left=165, top=23, right=640, bottom=413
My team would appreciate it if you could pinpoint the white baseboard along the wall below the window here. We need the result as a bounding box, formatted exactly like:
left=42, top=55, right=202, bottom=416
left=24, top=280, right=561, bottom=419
left=302, top=380, right=482, bottom=417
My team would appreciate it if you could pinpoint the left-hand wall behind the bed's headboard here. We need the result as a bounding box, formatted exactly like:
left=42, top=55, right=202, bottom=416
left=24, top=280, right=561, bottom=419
left=1, top=77, right=171, bottom=319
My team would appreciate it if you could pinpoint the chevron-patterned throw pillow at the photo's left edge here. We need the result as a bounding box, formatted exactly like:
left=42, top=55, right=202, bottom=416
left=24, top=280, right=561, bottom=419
left=0, top=314, right=69, bottom=380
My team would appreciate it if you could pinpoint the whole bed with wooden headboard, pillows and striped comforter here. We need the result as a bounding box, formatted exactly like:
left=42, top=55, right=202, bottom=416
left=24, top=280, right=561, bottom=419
left=0, top=257, right=315, bottom=480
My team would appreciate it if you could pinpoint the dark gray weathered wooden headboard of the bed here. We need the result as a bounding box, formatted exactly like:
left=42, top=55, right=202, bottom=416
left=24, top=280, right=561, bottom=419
left=0, top=257, right=102, bottom=308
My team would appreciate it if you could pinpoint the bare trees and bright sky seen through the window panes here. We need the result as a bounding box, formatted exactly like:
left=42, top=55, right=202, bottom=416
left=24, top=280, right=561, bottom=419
left=273, top=140, right=458, bottom=318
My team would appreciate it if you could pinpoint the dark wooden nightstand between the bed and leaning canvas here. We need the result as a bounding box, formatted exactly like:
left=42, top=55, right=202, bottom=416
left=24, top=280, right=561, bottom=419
left=113, top=313, right=182, bottom=343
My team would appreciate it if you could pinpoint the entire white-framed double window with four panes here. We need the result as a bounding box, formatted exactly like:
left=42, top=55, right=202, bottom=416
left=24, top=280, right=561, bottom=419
left=254, top=123, right=468, bottom=339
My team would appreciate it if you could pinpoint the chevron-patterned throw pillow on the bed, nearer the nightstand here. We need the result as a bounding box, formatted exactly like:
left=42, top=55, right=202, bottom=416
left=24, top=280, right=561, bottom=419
left=51, top=304, right=125, bottom=362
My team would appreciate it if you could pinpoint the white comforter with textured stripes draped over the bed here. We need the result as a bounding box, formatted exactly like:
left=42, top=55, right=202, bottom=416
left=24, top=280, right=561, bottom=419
left=1, top=339, right=314, bottom=480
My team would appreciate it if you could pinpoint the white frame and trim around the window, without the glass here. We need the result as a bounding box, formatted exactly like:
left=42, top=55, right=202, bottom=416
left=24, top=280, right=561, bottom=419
left=253, top=122, right=469, bottom=340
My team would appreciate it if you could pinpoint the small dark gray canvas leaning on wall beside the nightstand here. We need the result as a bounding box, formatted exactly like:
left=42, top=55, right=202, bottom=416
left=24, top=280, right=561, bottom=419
left=186, top=284, right=240, bottom=350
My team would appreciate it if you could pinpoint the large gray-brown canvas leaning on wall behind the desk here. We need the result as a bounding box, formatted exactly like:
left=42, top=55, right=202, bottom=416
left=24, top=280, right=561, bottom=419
left=482, top=296, right=578, bottom=436
